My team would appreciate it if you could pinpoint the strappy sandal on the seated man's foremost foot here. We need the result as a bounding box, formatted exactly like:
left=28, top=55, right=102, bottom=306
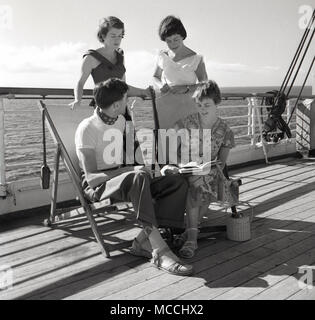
left=150, top=247, right=193, bottom=276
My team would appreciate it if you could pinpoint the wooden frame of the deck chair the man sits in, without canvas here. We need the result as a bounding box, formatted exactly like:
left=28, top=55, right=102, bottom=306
left=39, top=100, right=129, bottom=258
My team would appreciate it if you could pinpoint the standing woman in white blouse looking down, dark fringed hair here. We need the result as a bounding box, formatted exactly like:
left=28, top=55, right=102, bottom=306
left=153, top=16, right=208, bottom=93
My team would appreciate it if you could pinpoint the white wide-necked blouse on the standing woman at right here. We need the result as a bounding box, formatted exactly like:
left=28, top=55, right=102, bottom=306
left=157, top=51, right=203, bottom=86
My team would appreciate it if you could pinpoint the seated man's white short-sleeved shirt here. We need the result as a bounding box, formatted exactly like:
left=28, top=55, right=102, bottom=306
left=75, top=110, right=126, bottom=170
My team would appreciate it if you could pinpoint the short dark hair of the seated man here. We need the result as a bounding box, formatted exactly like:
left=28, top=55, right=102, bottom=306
left=93, top=78, right=128, bottom=109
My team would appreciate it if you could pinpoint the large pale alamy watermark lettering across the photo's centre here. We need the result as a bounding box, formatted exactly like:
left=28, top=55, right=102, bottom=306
left=103, top=122, right=211, bottom=172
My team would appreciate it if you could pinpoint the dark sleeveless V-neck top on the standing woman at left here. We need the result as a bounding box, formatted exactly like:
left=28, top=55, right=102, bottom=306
left=83, top=50, right=126, bottom=84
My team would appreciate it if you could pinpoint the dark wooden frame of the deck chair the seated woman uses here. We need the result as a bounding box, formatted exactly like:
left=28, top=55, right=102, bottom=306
left=150, top=88, right=242, bottom=233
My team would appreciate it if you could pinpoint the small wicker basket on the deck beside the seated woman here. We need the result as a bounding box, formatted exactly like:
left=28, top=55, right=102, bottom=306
left=226, top=215, right=251, bottom=241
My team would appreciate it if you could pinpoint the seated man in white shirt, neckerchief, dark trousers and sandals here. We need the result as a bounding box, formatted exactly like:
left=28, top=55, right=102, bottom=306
left=75, top=78, right=193, bottom=275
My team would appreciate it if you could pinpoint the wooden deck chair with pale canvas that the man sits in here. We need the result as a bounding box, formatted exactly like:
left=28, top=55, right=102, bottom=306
left=39, top=101, right=132, bottom=257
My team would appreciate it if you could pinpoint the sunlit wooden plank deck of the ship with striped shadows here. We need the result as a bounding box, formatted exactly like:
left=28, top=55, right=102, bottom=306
left=0, top=158, right=315, bottom=300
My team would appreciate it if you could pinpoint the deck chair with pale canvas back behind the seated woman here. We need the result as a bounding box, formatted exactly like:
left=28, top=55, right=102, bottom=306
left=151, top=92, right=242, bottom=233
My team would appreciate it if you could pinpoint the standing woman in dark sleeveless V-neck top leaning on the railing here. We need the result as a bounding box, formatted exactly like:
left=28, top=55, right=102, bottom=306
left=69, top=16, right=150, bottom=111
